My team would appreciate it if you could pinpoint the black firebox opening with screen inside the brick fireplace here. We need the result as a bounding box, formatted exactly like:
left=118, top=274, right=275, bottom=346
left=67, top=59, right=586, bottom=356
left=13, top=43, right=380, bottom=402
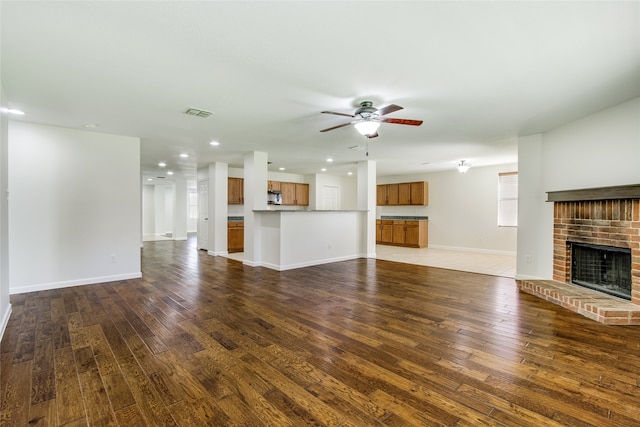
left=570, top=242, right=631, bottom=300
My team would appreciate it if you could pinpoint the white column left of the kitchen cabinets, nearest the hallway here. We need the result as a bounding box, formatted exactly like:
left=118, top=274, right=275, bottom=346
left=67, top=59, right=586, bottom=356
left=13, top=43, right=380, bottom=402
left=208, top=162, right=229, bottom=256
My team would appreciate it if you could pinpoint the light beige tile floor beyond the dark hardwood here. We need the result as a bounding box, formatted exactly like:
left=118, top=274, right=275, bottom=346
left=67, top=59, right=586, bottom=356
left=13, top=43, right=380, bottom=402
left=222, top=245, right=516, bottom=278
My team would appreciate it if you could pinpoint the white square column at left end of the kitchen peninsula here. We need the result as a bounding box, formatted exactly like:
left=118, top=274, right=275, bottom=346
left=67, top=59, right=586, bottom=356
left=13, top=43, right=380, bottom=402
left=243, top=151, right=268, bottom=266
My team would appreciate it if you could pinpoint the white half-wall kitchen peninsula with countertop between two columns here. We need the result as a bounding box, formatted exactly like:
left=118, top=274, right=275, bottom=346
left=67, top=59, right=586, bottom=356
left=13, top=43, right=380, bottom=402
left=253, top=210, right=374, bottom=271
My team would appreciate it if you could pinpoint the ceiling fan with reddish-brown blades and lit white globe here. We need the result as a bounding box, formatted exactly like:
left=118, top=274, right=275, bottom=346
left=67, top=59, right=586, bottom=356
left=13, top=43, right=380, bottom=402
left=320, top=101, right=422, bottom=138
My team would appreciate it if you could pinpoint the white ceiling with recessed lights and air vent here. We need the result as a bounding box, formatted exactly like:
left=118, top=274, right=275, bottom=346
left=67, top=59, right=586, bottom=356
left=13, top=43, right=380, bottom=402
left=0, top=1, right=640, bottom=184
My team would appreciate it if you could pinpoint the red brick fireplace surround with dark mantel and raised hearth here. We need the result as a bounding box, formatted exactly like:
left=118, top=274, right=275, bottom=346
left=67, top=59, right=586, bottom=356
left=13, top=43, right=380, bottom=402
left=518, top=185, right=640, bottom=325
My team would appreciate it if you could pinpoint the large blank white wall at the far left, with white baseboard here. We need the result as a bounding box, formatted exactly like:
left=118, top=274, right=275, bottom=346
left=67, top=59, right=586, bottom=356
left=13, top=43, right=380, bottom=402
left=9, top=121, right=141, bottom=293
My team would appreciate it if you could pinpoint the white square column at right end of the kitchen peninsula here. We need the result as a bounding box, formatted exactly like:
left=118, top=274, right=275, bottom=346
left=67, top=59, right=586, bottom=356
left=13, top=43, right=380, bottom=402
left=357, top=160, right=376, bottom=258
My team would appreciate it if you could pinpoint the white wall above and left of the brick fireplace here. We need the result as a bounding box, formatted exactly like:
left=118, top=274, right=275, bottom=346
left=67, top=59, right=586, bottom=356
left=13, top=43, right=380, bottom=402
left=516, top=98, right=640, bottom=279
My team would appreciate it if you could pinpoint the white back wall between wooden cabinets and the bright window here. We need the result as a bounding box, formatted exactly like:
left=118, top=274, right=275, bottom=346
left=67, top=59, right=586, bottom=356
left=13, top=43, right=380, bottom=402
left=377, top=164, right=518, bottom=254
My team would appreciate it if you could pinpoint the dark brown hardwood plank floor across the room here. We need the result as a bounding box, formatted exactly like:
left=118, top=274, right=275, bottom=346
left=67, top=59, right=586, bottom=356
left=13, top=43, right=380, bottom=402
left=0, top=241, right=640, bottom=427
